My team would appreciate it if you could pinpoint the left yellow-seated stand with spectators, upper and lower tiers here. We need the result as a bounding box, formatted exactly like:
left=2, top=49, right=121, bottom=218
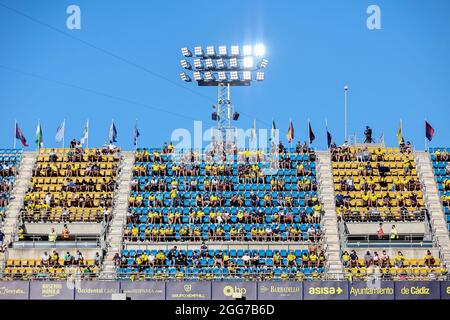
left=0, top=142, right=121, bottom=279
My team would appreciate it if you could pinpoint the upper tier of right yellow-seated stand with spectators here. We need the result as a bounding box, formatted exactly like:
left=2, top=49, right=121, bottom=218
left=332, top=145, right=425, bottom=222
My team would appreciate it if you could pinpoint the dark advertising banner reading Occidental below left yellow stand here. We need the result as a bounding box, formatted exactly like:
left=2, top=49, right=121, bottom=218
left=75, top=281, right=119, bottom=300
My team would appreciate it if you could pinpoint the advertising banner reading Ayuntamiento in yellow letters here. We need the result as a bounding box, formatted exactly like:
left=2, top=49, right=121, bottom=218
left=348, top=280, right=395, bottom=300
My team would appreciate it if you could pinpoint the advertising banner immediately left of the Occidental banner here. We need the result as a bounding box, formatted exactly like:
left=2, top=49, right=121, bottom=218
left=30, top=281, right=74, bottom=300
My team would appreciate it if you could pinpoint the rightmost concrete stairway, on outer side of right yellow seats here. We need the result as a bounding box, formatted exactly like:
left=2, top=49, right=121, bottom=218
left=414, top=151, right=450, bottom=266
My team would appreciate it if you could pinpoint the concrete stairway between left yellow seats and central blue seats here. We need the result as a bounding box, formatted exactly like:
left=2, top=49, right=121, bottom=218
left=100, top=151, right=134, bottom=278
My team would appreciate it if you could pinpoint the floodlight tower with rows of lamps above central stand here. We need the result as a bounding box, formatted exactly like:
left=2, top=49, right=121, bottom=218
left=180, top=44, right=268, bottom=140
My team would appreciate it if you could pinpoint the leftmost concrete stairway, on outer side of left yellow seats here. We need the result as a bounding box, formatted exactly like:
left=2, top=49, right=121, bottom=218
left=0, top=152, right=37, bottom=265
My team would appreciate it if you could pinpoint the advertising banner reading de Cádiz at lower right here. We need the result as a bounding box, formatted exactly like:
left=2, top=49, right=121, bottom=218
left=395, top=281, right=441, bottom=300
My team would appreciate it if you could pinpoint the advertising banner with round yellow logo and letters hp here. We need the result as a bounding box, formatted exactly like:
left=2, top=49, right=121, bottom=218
left=212, top=281, right=257, bottom=300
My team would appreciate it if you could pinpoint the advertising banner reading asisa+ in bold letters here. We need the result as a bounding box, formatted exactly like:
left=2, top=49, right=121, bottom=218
left=303, top=281, right=348, bottom=300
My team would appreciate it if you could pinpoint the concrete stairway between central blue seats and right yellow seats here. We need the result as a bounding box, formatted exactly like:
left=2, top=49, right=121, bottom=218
left=316, top=151, right=344, bottom=277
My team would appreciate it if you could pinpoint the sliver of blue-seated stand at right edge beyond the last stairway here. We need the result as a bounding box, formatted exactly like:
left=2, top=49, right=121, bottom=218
left=429, top=148, right=450, bottom=231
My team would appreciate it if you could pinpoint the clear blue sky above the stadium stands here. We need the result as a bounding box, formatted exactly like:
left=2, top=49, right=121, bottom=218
left=0, top=0, right=450, bottom=150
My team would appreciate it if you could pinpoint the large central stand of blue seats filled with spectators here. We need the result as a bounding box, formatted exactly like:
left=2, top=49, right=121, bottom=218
left=114, top=145, right=325, bottom=278
